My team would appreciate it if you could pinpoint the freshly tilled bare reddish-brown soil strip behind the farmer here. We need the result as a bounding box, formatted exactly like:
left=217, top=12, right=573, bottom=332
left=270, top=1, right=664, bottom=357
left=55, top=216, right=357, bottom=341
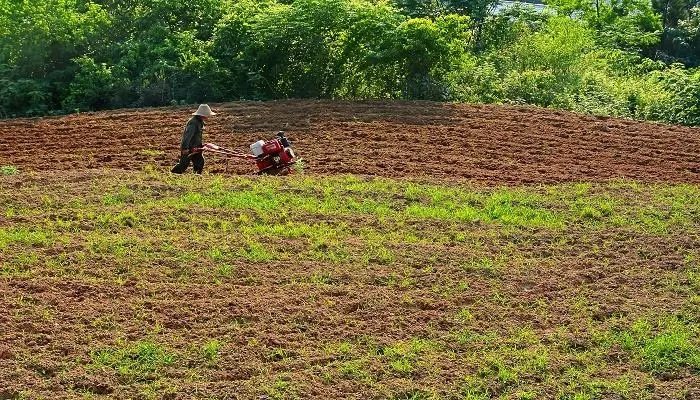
left=0, top=100, right=700, bottom=184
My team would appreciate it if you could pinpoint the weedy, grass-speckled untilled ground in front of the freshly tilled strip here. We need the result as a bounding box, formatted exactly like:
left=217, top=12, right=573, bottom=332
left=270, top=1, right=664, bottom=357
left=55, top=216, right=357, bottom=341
left=0, top=171, right=700, bottom=399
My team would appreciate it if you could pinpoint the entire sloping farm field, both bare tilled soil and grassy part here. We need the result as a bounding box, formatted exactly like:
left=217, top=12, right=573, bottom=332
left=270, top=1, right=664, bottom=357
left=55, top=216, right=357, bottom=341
left=0, top=101, right=700, bottom=400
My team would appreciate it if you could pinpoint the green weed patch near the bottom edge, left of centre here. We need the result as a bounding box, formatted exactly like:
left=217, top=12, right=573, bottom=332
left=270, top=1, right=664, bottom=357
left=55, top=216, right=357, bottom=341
left=90, top=341, right=175, bottom=382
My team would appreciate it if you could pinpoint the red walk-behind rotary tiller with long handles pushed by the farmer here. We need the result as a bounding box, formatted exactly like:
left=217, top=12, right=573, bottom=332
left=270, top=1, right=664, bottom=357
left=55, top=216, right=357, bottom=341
left=197, top=131, right=297, bottom=175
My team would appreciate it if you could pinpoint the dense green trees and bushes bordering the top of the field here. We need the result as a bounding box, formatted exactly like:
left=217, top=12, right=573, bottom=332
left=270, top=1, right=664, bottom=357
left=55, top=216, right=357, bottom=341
left=0, top=0, right=700, bottom=125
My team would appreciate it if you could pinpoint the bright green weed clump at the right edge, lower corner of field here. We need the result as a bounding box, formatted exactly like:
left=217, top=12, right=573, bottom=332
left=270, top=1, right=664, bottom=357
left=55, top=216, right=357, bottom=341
left=618, top=317, right=700, bottom=376
